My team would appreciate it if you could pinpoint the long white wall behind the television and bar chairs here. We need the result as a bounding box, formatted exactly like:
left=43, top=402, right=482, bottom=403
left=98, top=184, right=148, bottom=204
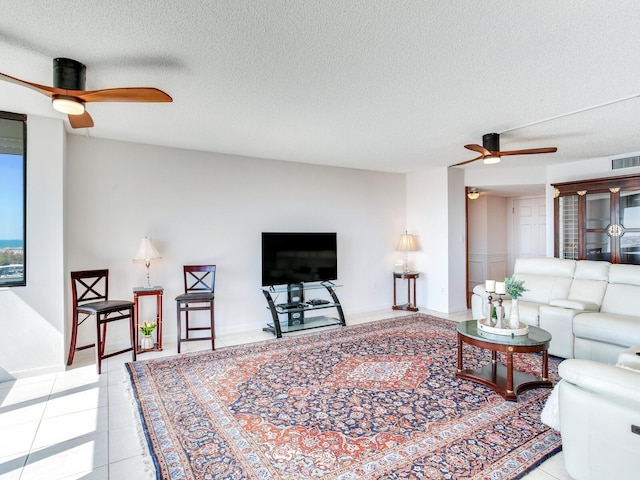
left=65, top=135, right=406, bottom=348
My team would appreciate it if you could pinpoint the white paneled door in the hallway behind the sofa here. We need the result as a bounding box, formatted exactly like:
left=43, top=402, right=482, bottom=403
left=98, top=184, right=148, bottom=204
left=513, top=197, right=547, bottom=259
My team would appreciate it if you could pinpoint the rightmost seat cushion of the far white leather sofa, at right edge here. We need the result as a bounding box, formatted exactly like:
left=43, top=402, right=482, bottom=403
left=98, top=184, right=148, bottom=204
left=573, top=312, right=640, bottom=347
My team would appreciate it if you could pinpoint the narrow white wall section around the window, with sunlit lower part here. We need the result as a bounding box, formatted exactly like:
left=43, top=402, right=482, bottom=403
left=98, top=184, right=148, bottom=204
left=0, top=116, right=65, bottom=381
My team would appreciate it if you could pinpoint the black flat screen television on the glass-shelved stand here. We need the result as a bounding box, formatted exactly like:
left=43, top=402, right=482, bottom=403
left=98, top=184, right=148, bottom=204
left=262, top=232, right=338, bottom=287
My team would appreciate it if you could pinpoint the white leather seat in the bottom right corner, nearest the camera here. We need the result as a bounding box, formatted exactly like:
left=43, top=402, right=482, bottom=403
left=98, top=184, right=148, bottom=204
left=558, top=354, right=640, bottom=480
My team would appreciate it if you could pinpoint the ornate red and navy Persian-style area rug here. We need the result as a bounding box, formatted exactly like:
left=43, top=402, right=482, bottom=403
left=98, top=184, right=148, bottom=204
left=126, top=314, right=561, bottom=480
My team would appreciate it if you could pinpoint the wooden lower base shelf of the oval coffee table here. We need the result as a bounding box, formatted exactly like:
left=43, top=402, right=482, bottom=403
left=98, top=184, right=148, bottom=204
left=456, top=362, right=553, bottom=402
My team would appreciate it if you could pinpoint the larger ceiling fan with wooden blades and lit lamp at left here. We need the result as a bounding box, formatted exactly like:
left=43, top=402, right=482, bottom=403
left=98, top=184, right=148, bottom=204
left=0, top=58, right=173, bottom=128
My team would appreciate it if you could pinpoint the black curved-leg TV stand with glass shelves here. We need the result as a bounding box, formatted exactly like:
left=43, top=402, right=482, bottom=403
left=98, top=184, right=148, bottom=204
left=262, top=282, right=346, bottom=338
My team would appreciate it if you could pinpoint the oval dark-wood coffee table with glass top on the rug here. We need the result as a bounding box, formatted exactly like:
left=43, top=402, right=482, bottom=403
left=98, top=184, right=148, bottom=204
left=456, top=320, right=553, bottom=402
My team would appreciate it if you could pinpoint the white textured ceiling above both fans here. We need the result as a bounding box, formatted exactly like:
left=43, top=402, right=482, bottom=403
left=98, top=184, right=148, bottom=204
left=0, top=0, right=640, bottom=172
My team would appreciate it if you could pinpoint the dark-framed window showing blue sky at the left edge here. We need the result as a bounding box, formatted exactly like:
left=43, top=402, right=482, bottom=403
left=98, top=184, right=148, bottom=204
left=0, top=112, right=27, bottom=287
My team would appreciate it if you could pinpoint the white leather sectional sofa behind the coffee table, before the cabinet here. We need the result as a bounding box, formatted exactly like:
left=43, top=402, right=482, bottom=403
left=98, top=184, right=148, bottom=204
left=471, top=257, right=640, bottom=364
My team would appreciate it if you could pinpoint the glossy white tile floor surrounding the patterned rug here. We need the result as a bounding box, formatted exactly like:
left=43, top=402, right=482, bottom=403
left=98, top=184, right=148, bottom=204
left=0, top=311, right=571, bottom=480
